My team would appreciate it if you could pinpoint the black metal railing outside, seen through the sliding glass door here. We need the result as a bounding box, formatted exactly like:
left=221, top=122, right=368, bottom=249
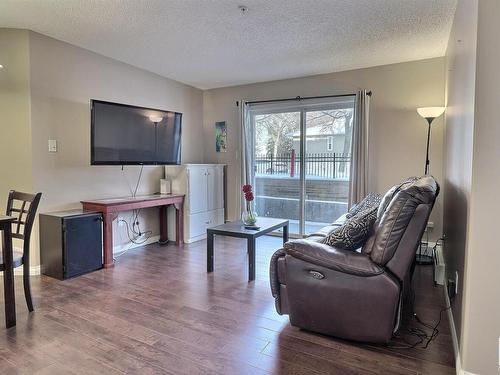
left=254, top=152, right=351, bottom=179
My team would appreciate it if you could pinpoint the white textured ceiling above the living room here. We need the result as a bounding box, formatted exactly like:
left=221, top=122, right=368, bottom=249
left=0, top=0, right=456, bottom=89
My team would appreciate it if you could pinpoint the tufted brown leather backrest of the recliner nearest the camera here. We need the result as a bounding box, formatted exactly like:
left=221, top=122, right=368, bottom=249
left=362, top=176, right=439, bottom=280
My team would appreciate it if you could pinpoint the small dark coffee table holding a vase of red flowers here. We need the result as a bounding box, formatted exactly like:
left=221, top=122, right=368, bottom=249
left=207, top=217, right=288, bottom=281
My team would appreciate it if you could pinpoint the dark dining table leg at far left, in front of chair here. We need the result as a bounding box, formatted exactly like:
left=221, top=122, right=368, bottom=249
left=3, top=223, right=16, bottom=328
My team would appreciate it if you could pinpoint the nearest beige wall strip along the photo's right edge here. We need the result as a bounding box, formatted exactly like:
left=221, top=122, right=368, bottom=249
left=461, top=0, right=500, bottom=374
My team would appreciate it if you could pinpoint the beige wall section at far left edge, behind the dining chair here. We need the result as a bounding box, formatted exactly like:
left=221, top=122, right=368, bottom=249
left=0, top=29, right=33, bottom=213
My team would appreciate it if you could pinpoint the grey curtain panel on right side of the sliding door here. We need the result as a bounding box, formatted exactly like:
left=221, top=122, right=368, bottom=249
left=349, top=90, right=370, bottom=207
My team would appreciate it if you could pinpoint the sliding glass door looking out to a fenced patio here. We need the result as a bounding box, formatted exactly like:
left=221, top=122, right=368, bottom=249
left=250, top=96, right=354, bottom=237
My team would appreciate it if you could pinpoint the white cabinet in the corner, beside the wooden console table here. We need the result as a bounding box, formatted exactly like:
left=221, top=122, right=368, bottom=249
left=165, top=164, right=224, bottom=243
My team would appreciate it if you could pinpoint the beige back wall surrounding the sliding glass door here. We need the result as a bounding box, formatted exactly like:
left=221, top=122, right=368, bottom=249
left=203, top=58, right=445, bottom=239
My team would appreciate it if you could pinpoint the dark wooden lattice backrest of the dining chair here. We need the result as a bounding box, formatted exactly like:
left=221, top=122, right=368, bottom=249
left=5, top=190, right=42, bottom=260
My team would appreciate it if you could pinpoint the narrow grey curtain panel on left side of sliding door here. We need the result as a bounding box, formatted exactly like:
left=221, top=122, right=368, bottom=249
left=238, top=100, right=254, bottom=213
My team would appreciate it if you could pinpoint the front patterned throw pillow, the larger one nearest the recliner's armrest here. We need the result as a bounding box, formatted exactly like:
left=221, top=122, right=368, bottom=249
left=321, top=206, right=377, bottom=250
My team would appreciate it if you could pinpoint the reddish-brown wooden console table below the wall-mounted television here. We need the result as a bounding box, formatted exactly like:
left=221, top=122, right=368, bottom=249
left=81, top=194, right=184, bottom=268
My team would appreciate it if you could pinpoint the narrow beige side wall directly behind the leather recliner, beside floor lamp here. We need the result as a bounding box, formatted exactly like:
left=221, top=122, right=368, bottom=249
left=443, top=0, right=477, bottom=356
